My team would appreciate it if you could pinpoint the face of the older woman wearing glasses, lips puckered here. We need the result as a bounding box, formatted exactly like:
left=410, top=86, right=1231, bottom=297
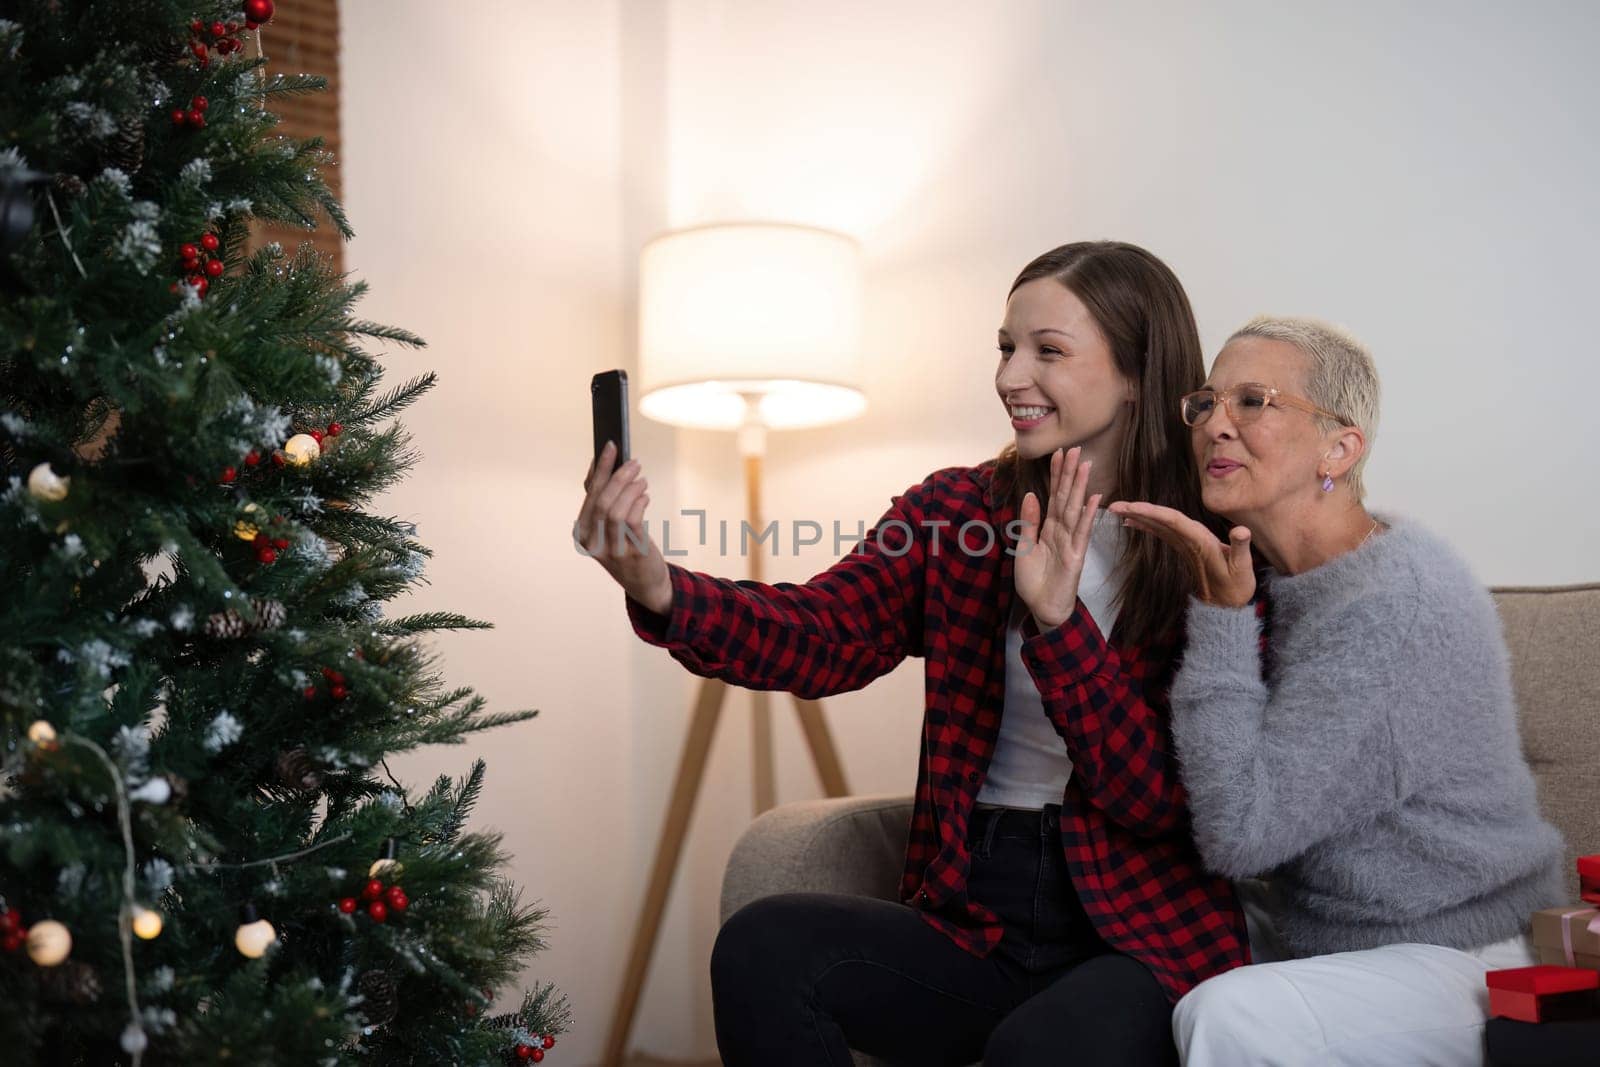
left=1190, top=338, right=1344, bottom=528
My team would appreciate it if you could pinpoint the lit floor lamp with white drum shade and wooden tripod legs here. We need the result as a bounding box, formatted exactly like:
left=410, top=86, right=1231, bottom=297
left=602, top=222, right=866, bottom=1067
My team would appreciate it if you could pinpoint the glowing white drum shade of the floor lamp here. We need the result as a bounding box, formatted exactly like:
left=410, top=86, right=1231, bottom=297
left=638, top=222, right=867, bottom=430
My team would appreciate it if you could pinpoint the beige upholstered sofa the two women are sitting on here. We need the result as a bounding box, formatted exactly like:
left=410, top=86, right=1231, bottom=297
left=722, top=584, right=1600, bottom=1065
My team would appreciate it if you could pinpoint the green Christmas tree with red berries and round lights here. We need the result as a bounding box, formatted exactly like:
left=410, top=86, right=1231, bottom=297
left=0, top=0, right=566, bottom=1067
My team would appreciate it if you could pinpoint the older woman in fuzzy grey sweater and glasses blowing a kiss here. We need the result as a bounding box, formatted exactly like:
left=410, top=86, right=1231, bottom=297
left=1110, top=318, right=1562, bottom=1067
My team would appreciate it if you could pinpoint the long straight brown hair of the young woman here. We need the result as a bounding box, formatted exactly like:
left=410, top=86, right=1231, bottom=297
left=995, top=242, right=1214, bottom=645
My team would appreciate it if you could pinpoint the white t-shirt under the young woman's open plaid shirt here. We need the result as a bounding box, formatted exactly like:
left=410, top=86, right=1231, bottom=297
left=978, top=512, right=1123, bottom=809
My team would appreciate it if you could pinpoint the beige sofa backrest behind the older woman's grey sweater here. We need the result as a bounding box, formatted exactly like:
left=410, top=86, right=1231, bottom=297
left=1493, top=585, right=1600, bottom=901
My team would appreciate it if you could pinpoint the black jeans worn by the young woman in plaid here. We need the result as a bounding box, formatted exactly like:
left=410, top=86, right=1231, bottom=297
left=710, top=805, right=1178, bottom=1067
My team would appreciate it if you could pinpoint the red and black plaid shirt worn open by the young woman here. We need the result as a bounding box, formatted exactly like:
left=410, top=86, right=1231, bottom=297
left=629, top=461, right=1250, bottom=1000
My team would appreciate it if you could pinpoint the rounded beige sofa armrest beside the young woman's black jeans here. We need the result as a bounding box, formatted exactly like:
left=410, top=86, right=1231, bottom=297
left=722, top=797, right=912, bottom=921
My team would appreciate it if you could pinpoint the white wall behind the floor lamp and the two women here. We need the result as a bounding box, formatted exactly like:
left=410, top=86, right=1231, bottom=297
left=344, top=0, right=1600, bottom=1064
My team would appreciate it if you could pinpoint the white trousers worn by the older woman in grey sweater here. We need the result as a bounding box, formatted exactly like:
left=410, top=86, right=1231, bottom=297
left=1173, top=889, right=1538, bottom=1067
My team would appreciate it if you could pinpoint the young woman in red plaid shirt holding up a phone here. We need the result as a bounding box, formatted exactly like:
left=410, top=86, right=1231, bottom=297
left=574, top=242, right=1246, bottom=1067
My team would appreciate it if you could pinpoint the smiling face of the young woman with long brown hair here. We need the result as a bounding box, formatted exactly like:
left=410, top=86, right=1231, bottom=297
left=995, top=278, right=1136, bottom=470
